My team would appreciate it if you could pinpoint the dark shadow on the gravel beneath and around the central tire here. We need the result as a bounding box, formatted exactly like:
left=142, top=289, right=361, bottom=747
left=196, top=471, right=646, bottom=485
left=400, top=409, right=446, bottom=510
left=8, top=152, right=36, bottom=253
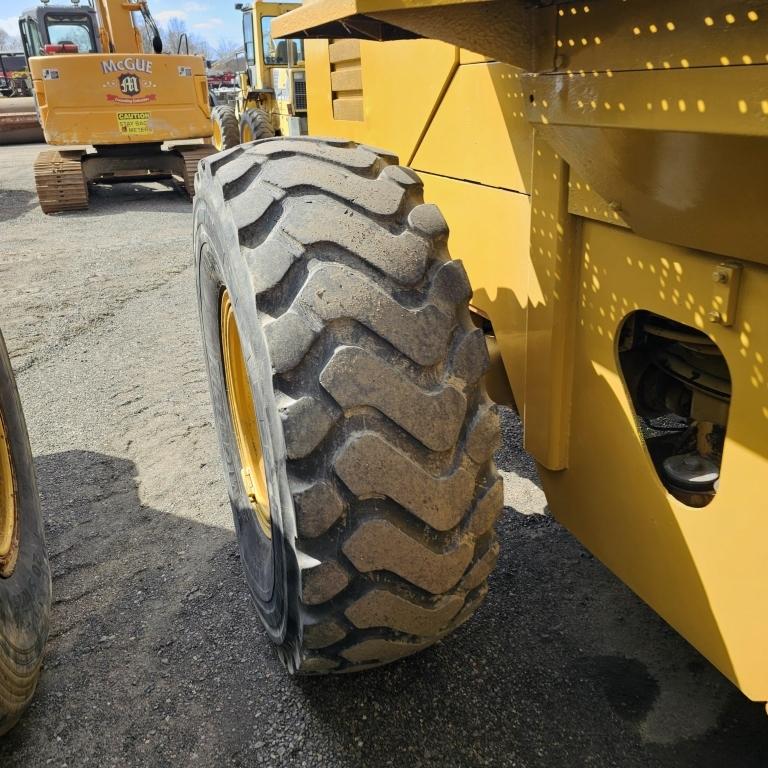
left=0, top=440, right=768, bottom=768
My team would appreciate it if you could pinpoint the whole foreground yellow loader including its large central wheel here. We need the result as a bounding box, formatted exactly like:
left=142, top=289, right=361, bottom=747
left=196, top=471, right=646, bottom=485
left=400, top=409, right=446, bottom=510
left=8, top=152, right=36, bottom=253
left=194, top=0, right=768, bottom=701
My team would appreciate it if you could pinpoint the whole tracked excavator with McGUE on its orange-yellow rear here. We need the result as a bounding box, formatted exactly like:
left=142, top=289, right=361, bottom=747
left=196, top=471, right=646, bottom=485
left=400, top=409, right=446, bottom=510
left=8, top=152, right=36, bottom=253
left=19, top=0, right=215, bottom=213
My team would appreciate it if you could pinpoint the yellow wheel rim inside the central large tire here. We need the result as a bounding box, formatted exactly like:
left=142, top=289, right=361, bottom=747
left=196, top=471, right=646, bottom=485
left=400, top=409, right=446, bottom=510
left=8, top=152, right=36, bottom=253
left=220, top=290, right=272, bottom=539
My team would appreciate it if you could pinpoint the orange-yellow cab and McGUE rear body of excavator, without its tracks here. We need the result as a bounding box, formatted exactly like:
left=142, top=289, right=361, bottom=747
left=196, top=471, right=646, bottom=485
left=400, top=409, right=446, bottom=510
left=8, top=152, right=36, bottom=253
left=22, top=0, right=211, bottom=146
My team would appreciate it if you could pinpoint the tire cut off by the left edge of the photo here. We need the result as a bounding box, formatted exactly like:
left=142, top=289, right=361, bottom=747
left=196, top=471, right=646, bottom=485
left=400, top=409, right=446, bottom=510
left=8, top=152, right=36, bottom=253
left=0, top=328, right=51, bottom=735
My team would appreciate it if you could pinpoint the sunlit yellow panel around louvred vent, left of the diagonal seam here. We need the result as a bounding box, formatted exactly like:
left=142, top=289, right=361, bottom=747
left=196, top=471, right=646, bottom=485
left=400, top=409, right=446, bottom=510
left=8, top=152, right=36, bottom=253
left=306, top=40, right=458, bottom=162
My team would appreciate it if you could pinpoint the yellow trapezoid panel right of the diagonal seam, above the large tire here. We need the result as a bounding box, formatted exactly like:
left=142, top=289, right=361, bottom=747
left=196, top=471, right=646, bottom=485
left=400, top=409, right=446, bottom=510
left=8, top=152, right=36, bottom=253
left=411, top=63, right=532, bottom=192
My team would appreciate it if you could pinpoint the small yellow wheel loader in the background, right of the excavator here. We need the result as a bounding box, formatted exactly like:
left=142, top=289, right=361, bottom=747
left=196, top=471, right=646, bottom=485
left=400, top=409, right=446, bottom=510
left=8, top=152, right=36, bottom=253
left=211, top=0, right=307, bottom=150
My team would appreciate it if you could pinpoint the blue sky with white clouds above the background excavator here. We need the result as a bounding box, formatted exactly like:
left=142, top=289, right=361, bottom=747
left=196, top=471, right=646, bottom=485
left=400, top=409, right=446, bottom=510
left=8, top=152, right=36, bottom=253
left=0, top=0, right=272, bottom=48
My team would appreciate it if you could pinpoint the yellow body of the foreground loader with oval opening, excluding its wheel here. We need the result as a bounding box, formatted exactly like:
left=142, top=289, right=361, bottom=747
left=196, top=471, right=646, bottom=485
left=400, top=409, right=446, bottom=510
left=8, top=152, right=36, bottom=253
left=275, top=0, right=768, bottom=700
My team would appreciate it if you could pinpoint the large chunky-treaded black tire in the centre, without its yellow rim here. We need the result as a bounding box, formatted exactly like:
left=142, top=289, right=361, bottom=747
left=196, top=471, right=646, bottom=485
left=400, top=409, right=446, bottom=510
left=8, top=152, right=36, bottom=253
left=194, top=138, right=503, bottom=672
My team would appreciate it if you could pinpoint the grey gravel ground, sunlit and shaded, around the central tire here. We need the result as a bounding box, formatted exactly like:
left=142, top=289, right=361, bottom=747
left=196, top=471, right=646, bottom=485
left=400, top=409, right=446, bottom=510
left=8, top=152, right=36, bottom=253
left=0, top=146, right=768, bottom=768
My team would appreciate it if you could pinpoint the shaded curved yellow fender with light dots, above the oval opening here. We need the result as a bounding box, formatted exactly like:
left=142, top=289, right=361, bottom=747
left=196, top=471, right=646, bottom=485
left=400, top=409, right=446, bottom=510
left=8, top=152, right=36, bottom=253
left=523, top=66, right=768, bottom=263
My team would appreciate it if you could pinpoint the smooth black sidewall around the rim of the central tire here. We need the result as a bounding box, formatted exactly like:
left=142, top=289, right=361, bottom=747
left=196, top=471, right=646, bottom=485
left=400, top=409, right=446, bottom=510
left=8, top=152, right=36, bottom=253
left=195, top=195, right=297, bottom=646
